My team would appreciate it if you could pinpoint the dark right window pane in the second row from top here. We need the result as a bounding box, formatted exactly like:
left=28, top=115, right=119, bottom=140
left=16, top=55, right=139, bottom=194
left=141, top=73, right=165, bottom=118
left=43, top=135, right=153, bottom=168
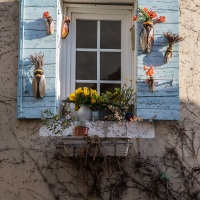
left=100, top=52, right=121, bottom=80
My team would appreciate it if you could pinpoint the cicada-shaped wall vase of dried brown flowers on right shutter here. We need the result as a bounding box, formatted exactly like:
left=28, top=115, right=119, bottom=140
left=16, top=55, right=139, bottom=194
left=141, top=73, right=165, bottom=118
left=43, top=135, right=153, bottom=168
left=163, top=32, right=183, bottom=63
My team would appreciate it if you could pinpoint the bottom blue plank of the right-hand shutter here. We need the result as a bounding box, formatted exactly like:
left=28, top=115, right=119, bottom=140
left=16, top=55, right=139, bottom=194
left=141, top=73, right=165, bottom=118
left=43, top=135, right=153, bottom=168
left=137, top=108, right=180, bottom=120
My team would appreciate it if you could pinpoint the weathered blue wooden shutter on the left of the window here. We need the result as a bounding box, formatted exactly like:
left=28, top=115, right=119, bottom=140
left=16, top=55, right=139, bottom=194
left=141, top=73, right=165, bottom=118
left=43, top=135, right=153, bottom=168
left=17, top=0, right=58, bottom=118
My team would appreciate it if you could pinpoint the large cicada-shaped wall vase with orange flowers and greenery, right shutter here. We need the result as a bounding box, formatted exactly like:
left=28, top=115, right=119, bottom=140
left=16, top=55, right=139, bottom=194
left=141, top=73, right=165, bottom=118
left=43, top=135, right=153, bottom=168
left=132, top=5, right=165, bottom=53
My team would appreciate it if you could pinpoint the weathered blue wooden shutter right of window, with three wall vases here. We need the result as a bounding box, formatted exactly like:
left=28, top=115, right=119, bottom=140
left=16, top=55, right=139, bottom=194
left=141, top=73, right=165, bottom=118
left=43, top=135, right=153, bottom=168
left=136, top=0, right=179, bottom=120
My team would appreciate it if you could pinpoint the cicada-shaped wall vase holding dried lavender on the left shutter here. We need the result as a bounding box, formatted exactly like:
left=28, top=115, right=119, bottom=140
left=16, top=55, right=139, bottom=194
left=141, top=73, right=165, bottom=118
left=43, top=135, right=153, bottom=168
left=30, top=53, right=46, bottom=98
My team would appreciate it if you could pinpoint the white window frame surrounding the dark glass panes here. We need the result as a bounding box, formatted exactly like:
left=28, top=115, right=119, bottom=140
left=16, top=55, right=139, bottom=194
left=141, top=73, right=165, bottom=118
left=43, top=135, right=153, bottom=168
left=60, top=3, right=136, bottom=99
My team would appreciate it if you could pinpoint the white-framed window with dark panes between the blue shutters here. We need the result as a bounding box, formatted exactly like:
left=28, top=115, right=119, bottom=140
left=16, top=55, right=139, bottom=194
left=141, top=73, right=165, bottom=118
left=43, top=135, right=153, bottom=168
left=61, top=4, right=133, bottom=98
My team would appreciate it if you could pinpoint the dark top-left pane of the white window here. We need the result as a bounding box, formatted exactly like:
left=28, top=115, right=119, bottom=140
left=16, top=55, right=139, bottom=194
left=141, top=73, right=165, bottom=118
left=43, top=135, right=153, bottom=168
left=76, top=20, right=97, bottom=48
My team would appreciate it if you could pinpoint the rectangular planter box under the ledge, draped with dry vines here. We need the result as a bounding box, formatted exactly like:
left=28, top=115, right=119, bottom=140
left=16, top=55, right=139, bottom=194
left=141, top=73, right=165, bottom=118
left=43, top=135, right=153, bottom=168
left=57, top=135, right=131, bottom=157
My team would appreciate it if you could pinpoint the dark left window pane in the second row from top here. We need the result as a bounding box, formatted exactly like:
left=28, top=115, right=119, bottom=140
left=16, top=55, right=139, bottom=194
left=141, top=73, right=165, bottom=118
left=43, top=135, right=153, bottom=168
left=76, top=52, right=97, bottom=80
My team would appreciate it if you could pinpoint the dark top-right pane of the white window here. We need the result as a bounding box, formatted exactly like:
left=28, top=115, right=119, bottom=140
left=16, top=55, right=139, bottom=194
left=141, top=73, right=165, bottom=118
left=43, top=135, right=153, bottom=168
left=100, top=21, right=121, bottom=49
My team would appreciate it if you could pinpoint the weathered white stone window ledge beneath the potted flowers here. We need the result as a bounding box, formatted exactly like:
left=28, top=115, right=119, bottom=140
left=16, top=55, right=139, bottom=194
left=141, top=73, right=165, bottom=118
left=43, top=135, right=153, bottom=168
left=39, top=121, right=155, bottom=138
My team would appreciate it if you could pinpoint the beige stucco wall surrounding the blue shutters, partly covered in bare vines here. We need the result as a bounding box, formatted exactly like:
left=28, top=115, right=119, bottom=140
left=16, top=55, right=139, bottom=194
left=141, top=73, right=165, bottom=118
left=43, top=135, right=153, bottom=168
left=0, top=0, right=200, bottom=200
